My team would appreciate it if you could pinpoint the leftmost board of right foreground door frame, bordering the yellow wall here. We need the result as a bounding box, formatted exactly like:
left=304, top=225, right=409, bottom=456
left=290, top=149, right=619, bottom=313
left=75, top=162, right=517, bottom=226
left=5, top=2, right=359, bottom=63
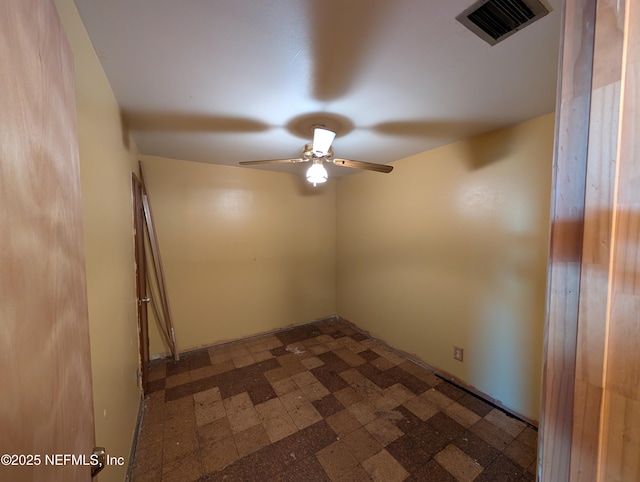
left=538, top=0, right=596, bottom=481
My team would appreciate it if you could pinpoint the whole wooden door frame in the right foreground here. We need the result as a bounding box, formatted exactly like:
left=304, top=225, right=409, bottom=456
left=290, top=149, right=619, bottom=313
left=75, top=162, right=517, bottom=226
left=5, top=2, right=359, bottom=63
left=538, top=0, right=640, bottom=482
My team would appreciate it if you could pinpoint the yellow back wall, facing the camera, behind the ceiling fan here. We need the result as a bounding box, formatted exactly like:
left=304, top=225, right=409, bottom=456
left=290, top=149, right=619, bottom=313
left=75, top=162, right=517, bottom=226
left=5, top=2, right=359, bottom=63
left=142, top=156, right=336, bottom=354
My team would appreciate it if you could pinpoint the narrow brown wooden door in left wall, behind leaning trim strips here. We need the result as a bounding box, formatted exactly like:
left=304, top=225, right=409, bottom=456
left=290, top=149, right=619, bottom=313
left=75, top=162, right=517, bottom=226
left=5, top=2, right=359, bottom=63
left=131, top=174, right=149, bottom=394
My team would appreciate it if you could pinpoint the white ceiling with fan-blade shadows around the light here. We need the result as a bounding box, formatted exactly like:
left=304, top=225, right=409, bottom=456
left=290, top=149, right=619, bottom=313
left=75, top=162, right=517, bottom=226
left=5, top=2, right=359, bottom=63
left=75, top=0, right=561, bottom=175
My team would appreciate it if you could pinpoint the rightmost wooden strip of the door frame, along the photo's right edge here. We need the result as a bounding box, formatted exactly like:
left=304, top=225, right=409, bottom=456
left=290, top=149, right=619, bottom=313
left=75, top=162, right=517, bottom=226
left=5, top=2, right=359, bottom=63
left=599, top=1, right=640, bottom=474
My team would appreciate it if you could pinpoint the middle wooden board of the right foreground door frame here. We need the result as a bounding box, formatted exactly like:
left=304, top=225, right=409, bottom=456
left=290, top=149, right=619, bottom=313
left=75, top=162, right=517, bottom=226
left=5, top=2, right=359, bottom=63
left=571, top=0, right=624, bottom=481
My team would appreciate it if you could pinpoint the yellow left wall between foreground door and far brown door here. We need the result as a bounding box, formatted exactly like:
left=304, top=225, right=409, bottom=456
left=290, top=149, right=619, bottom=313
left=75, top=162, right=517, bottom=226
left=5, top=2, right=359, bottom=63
left=55, top=0, right=140, bottom=482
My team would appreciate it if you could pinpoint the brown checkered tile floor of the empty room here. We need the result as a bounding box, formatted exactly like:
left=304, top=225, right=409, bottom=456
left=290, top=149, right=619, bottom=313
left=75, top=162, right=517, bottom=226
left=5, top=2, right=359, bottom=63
left=132, top=320, right=537, bottom=482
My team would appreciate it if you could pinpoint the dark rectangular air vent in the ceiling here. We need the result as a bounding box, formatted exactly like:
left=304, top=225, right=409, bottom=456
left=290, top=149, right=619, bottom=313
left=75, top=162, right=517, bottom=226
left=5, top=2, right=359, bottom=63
left=456, top=0, right=549, bottom=45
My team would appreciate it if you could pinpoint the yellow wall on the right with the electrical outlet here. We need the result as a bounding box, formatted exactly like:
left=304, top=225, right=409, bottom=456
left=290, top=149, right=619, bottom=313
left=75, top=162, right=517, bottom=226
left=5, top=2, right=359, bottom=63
left=337, top=115, right=554, bottom=420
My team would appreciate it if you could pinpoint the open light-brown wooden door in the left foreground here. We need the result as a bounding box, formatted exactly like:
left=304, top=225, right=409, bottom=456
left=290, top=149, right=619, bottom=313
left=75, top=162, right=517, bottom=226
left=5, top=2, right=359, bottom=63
left=0, top=0, right=95, bottom=482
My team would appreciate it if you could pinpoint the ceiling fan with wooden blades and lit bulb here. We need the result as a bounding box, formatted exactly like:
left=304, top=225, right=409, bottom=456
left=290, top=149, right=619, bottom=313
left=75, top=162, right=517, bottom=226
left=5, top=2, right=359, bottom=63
left=240, top=126, right=393, bottom=186
